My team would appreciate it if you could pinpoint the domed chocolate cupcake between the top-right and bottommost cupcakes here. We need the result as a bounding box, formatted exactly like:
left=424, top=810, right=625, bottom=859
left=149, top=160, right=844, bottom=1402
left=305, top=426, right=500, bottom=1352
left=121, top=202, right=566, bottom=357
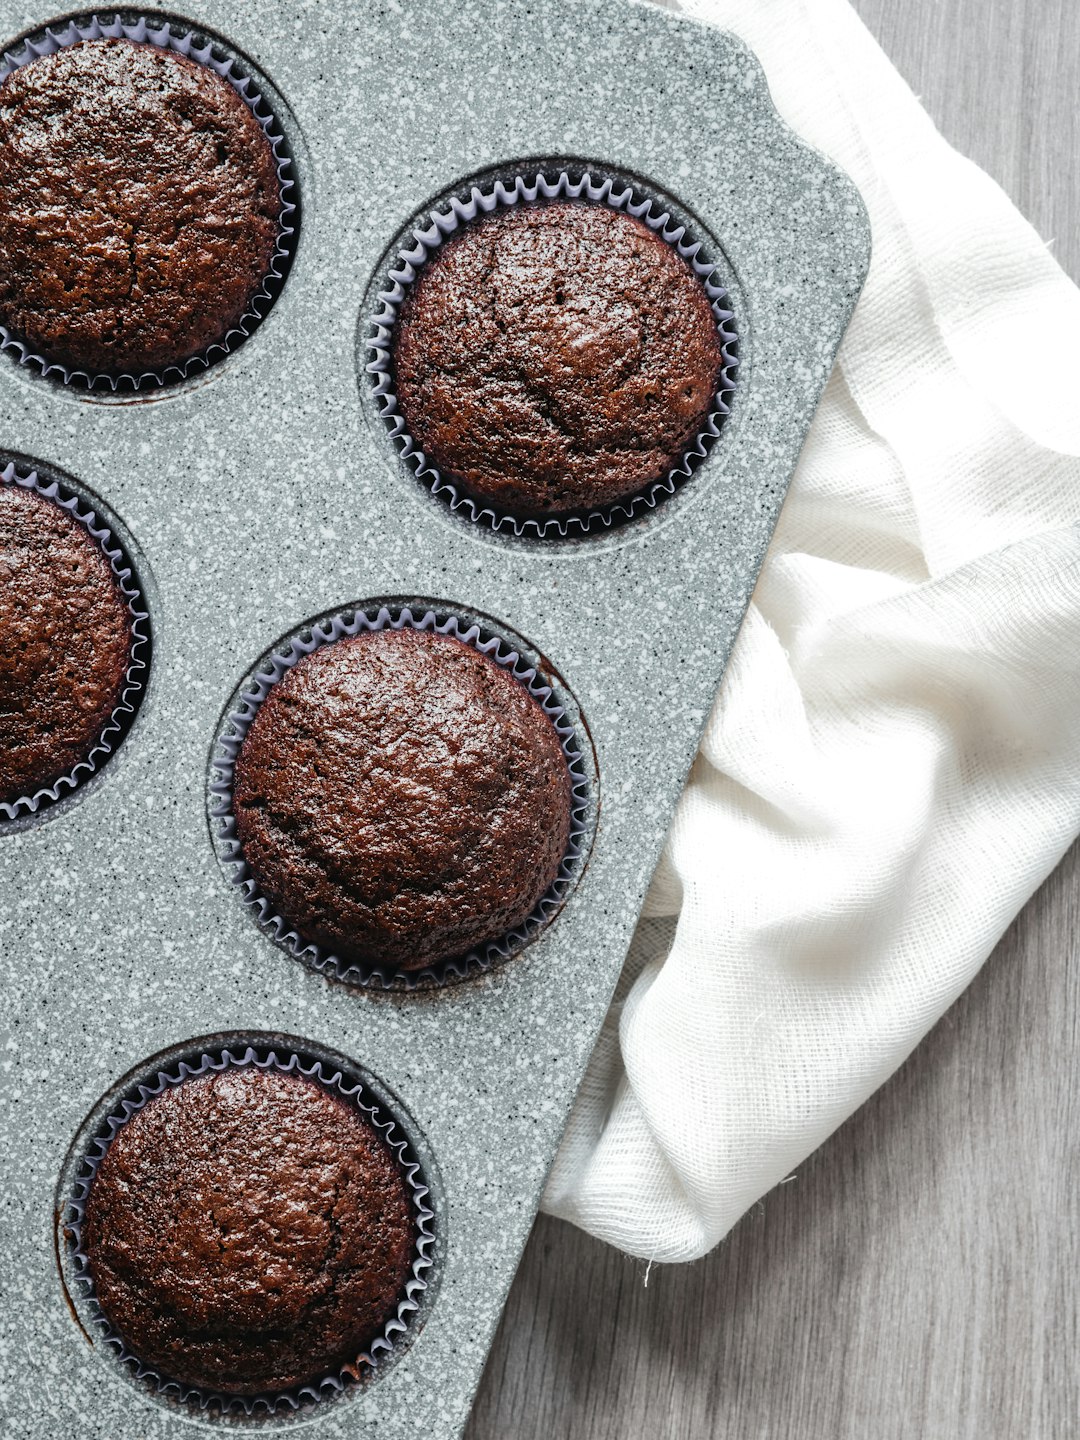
left=233, top=628, right=572, bottom=971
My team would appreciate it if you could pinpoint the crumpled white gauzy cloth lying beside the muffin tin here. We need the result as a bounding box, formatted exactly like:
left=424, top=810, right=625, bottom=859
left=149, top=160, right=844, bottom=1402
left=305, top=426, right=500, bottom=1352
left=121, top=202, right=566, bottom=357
left=544, top=0, right=1080, bottom=1260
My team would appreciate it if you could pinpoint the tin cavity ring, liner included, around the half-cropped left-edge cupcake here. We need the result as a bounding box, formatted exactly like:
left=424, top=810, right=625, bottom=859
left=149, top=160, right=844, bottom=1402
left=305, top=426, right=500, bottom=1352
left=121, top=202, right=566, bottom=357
left=0, top=454, right=153, bottom=831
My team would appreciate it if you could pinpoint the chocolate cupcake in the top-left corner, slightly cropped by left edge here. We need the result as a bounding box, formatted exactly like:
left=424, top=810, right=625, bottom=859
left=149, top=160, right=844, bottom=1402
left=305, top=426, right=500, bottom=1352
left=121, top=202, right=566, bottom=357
left=0, top=37, right=282, bottom=377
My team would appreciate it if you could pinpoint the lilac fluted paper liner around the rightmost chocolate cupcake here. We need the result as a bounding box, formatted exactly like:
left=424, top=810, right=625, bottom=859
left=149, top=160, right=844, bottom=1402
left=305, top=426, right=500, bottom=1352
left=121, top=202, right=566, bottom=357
left=364, top=170, right=739, bottom=540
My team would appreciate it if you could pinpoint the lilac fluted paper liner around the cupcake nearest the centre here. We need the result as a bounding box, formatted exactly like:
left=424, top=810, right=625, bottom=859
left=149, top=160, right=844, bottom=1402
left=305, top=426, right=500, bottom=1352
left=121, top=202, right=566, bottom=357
left=209, top=605, right=589, bottom=989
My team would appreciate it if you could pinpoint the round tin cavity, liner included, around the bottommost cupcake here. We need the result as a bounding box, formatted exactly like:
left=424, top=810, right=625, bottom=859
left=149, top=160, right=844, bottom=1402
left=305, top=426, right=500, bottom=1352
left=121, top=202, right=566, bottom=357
left=56, top=1032, right=439, bottom=1426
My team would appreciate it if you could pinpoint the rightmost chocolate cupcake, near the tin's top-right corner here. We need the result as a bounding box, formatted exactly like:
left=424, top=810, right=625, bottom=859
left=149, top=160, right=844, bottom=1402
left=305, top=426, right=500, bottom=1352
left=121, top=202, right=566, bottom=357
left=392, top=200, right=724, bottom=517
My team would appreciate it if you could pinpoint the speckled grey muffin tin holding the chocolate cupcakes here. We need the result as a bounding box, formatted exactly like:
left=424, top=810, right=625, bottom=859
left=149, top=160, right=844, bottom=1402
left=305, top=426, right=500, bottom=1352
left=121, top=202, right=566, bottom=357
left=0, top=0, right=870, bottom=1440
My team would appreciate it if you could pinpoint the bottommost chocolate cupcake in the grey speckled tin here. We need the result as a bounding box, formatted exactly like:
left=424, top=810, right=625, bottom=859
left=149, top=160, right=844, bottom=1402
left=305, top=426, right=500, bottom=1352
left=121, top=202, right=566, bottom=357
left=81, top=1066, right=416, bottom=1395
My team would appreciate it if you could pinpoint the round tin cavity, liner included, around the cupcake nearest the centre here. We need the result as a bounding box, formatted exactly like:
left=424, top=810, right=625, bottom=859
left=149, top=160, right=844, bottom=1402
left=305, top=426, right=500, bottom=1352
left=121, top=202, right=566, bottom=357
left=207, top=599, right=598, bottom=991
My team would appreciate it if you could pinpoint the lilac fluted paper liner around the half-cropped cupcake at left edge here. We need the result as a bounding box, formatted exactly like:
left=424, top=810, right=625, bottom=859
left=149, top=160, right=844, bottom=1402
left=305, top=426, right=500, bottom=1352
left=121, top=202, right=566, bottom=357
left=0, top=462, right=150, bottom=819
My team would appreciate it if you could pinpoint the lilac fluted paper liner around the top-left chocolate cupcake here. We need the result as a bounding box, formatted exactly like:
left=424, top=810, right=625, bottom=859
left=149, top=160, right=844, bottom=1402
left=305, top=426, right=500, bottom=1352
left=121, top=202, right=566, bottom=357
left=0, top=14, right=297, bottom=390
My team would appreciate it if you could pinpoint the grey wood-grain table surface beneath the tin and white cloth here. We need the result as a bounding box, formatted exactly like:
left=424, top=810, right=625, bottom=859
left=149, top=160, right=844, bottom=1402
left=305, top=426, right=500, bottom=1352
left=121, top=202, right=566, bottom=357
left=467, top=0, right=1080, bottom=1440
